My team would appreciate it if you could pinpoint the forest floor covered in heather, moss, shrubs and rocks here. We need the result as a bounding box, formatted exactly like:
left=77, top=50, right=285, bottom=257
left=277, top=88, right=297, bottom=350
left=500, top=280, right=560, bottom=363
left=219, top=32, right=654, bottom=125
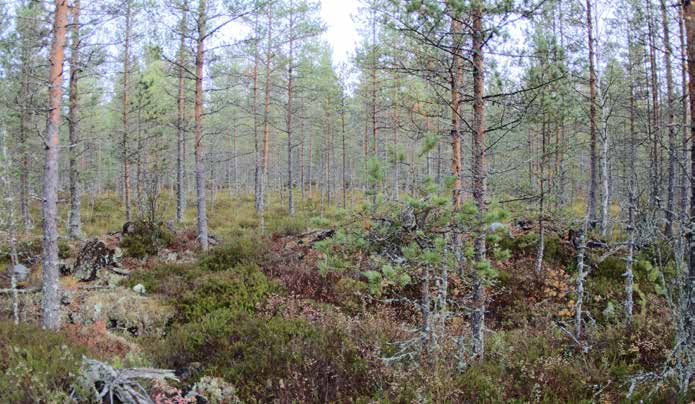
left=0, top=192, right=695, bottom=403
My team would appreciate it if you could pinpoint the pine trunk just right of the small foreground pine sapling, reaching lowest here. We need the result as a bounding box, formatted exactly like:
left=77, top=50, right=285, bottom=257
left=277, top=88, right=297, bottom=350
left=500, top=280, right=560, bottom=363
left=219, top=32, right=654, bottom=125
left=471, top=4, right=487, bottom=359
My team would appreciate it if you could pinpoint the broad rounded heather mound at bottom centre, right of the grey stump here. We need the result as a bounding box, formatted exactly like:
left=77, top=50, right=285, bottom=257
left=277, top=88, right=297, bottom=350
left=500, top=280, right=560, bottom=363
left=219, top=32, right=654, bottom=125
left=153, top=310, right=376, bottom=402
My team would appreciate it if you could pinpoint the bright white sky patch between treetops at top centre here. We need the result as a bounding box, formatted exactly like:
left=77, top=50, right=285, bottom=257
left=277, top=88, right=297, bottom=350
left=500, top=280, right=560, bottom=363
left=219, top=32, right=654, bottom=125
left=321, top=0, right=360, bottom=64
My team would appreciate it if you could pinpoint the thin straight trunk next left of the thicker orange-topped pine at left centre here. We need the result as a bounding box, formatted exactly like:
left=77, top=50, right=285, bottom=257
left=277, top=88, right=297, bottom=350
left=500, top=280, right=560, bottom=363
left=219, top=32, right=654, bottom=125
left=176, top=0, right=188, bottom=223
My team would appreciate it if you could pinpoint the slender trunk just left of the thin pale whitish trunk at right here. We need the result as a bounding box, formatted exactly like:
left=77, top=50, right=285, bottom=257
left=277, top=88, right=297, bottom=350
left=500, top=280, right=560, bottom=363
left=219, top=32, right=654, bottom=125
left=586, top=0, right=598, bottom=227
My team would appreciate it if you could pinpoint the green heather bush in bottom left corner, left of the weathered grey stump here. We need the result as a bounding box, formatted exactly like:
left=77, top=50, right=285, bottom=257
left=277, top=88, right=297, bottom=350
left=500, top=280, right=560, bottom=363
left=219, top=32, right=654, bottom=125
left=0, top=322, right=86, bottom=403
